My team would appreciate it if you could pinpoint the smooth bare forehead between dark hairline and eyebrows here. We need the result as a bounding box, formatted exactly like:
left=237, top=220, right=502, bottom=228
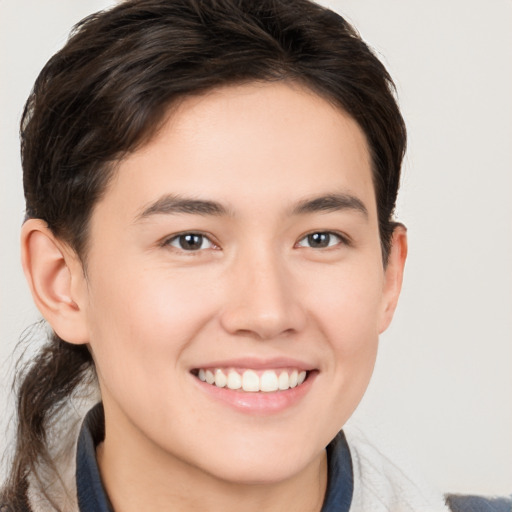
left=95, top=82, right=375, bottom=221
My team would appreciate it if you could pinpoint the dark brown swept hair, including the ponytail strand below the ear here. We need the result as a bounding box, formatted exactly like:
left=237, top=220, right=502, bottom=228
left=3, top=0, right=406, bottom=506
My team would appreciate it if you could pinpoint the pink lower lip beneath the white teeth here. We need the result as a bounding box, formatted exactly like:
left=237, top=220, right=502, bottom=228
left=192, top=371, right=318, bottom=415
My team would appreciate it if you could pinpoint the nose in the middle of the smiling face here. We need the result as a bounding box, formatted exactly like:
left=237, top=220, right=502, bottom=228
left=221, top=249, right=306, bottom=340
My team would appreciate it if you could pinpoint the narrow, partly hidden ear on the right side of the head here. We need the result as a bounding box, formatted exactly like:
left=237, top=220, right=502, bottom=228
left=379, top=224, right=407, bottom=333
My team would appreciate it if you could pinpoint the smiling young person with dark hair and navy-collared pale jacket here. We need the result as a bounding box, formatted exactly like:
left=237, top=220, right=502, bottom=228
left=6, top=0, right=508, bottom=512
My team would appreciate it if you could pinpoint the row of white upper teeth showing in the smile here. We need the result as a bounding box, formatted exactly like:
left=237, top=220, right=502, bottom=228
left=192, top=368, right=310, bottom=393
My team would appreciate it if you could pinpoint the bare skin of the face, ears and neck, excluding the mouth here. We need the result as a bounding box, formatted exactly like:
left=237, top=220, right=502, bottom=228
left=22, top=83, right=406, bottom=512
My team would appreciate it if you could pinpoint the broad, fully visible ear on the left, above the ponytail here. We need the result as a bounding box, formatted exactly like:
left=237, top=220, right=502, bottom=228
left=21, top=219, right=88, bottom=344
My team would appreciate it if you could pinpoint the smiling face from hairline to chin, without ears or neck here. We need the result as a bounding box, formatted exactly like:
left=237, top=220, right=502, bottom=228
left=76, top=83, right=404, bottom=482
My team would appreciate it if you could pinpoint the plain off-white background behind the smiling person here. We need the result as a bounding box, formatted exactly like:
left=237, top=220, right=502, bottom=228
left=0, top=0, right=512, bottom=494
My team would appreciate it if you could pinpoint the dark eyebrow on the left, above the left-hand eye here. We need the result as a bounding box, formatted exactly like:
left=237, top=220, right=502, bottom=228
left=135, top=194, right=229, bottom=221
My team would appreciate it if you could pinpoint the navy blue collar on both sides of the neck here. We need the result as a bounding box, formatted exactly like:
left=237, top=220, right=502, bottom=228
left=76, top=403, right=354, bottom=512
